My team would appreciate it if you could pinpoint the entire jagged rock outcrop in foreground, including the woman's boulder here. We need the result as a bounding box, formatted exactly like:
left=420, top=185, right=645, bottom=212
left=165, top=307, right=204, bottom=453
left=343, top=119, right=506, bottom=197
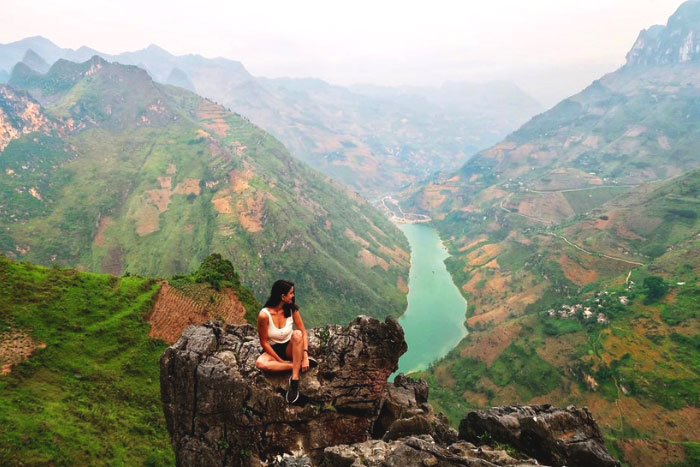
left=161, top=316, right=617, bottom=467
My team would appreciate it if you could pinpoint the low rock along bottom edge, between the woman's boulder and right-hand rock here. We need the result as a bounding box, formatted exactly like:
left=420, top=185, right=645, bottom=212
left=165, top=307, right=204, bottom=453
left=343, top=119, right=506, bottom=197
left=321, top=435, right=538, bottom=467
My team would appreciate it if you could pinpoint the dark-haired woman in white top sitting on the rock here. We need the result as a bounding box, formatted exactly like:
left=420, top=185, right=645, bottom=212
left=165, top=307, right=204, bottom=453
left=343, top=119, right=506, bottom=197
left=255, top=280, right=309, bottom=404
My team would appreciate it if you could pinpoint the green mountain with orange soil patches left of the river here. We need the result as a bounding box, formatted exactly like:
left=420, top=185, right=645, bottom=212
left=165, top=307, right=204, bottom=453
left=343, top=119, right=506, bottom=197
left=0, top=56, right=408, bottom=324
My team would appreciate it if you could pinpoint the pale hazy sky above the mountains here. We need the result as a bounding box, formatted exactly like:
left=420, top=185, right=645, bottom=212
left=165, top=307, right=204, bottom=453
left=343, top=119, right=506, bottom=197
left=0, top=0, right=681, bottom=105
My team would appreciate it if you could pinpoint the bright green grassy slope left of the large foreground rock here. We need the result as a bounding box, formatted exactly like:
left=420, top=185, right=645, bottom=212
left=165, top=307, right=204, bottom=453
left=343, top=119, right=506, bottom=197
left=0, top=257, right=174, bottom=465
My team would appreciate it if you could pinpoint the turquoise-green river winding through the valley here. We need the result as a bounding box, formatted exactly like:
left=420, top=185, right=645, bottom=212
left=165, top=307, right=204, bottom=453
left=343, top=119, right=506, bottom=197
left=397, top=224, right=467, bottom=373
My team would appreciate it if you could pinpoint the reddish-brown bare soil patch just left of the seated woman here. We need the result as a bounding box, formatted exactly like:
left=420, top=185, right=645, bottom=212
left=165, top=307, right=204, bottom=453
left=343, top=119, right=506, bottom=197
left=148, top=283, right=245, bottom=344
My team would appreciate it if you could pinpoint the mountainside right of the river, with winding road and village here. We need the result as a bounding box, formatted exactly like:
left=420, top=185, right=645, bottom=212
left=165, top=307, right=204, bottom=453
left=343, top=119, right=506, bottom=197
left=403, top=1, right=700, bottom=465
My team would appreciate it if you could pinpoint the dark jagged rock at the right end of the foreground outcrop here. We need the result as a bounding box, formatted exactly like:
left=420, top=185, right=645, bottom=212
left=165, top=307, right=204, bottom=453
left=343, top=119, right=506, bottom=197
left=459, top=405, right=620, bottom=467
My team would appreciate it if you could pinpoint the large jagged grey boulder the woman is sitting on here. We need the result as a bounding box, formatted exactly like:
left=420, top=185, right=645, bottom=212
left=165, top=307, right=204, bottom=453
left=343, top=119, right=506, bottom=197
left=160, top=316, right=406, bottom=466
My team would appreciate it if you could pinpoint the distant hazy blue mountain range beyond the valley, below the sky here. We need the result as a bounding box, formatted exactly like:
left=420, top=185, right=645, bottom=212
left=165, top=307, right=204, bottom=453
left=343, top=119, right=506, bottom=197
left=0, top=37, right=541, bottom=197
